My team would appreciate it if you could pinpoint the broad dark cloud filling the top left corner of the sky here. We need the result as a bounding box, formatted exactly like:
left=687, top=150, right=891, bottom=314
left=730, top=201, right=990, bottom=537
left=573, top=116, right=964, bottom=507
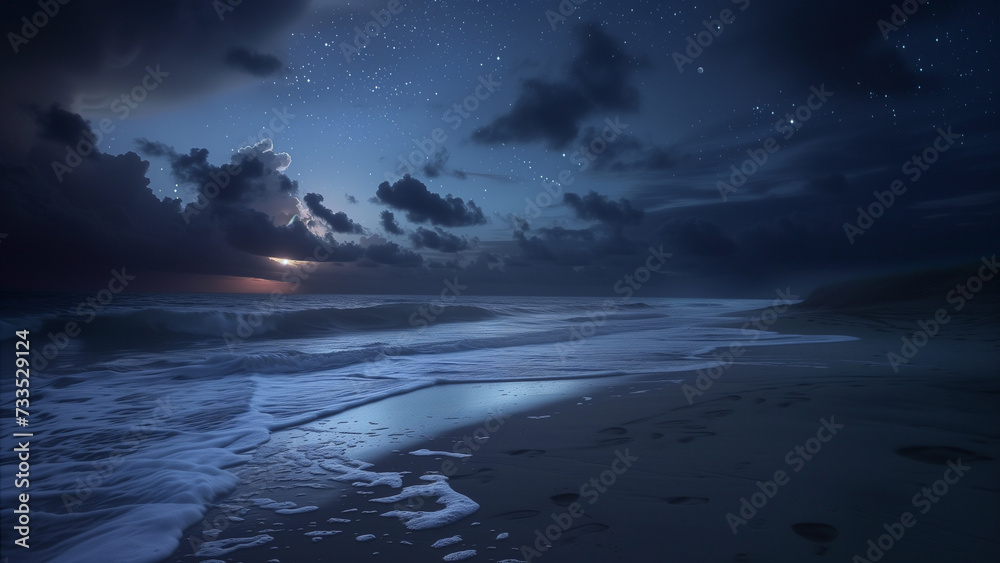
left=0, top=0, right=309, bottom=158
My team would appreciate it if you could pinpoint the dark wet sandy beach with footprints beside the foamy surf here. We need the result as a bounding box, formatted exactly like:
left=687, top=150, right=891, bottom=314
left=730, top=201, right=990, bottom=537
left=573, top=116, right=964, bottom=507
left=170, top=299, right=1000, bottom=563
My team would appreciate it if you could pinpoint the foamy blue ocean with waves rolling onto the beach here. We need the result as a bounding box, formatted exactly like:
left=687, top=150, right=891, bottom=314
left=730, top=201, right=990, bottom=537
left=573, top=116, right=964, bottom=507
left=0, top=294, right=849, bottom=563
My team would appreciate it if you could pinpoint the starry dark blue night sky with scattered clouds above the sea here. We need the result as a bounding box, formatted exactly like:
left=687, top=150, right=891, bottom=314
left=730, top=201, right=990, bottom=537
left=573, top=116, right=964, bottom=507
left=0, top=0, right=1000, bottom=297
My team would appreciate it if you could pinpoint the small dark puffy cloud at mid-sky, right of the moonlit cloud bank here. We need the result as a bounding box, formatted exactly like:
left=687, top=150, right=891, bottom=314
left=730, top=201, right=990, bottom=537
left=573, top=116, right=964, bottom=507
left=375, top=174, right=486, bottom=227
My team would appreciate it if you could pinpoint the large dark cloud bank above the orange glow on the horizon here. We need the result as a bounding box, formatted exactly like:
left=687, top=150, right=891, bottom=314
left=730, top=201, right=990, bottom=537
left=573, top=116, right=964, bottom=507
left=0, top=104, right=430, bottom=288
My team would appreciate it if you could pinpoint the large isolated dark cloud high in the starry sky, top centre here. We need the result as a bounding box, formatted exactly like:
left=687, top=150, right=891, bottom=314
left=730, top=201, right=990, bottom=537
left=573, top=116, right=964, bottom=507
left=472, top=24, right=643, bottom=149
